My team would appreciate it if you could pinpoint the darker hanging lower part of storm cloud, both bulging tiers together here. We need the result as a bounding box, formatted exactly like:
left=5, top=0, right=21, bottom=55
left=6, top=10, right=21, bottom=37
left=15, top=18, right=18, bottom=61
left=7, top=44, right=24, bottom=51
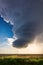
left=13, top=22, right=37, bottom=47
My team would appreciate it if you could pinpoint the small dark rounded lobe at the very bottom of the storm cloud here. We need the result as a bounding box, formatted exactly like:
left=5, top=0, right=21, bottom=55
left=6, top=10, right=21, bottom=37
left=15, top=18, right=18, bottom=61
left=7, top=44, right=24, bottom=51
left=12, top=39, right=27, bottom=48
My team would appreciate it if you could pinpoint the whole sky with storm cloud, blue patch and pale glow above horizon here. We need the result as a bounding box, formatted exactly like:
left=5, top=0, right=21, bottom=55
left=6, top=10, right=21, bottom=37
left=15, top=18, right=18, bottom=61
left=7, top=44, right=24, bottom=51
left=0, top=0, right=43, bottom=54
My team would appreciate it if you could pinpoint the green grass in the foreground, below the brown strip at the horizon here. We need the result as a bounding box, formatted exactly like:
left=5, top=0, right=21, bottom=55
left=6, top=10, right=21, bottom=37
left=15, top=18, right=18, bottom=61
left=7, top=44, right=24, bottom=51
left=0, top=56, right=43, bottom=65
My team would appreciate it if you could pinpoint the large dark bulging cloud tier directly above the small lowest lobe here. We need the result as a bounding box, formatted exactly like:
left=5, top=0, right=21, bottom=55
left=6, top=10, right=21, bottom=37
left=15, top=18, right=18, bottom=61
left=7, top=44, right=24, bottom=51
left=15, top=22, right=37, bottom=40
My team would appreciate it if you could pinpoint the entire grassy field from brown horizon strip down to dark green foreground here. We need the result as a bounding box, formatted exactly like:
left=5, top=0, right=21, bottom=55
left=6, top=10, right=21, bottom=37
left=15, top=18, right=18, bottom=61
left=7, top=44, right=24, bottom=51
left=0, top=55, right=43, bottom=65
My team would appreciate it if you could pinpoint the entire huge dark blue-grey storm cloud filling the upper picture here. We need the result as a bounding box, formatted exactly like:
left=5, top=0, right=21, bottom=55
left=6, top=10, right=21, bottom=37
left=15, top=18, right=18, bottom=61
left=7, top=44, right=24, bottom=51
left=0, top=0, right=43, bottom=47
